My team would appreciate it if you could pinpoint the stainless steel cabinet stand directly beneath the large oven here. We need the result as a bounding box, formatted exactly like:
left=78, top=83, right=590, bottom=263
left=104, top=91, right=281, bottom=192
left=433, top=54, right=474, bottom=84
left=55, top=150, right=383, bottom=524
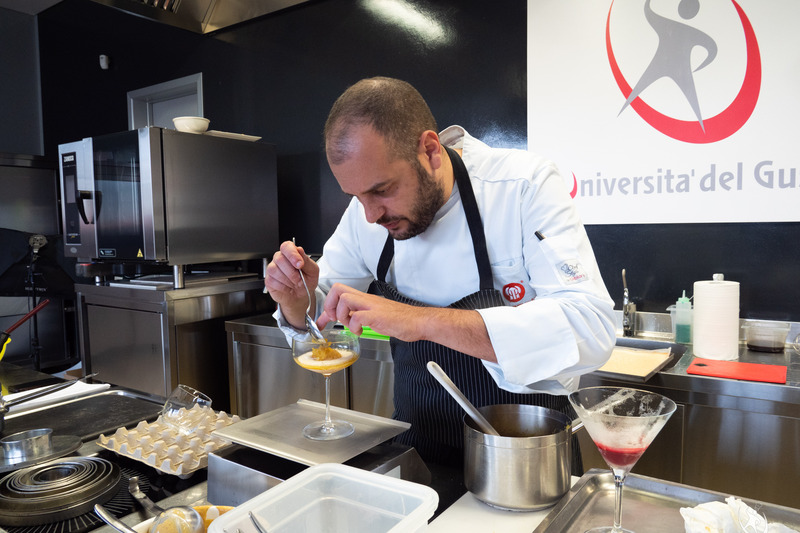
left=75, top=276, right=271, bottom=411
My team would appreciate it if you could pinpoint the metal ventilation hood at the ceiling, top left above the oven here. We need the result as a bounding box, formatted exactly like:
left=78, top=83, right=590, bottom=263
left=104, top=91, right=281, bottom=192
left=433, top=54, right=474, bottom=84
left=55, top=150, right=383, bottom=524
left=93, top=0, right=308, bottom=33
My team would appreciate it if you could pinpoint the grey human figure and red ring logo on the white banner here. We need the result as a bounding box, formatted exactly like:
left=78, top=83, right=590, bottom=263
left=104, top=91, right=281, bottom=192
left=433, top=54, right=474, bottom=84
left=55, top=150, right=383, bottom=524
left=606, top=0, right=761, bottom=143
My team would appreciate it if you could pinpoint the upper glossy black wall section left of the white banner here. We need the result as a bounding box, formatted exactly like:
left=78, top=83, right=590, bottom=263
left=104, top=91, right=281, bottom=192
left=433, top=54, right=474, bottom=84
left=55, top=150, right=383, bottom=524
left=39, top=0, right=526, bottom=251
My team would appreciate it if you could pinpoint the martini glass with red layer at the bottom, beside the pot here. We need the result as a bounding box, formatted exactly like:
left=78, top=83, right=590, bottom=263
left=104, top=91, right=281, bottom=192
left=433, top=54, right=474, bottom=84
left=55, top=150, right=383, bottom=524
left=569, top=387, right=675, bottom=533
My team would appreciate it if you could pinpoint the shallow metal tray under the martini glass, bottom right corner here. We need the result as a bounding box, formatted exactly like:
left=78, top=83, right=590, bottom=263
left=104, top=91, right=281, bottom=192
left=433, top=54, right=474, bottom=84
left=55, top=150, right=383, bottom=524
left=534, top=469, right=800, bottom=533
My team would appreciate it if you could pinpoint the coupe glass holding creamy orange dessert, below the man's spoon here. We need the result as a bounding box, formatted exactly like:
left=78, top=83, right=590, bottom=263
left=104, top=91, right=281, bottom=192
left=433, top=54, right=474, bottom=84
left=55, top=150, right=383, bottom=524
left=292, top=329, right=360, bottom=440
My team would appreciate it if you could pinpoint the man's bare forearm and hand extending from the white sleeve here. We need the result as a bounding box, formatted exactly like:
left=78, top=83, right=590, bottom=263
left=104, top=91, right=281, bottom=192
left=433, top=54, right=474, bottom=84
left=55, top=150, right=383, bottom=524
left=317, top=283, right=497, bottom=363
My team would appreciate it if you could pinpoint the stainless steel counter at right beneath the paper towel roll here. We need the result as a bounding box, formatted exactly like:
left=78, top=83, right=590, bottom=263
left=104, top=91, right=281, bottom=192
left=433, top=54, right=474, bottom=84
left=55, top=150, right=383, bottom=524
left=581, top=315, right=800, bottom=507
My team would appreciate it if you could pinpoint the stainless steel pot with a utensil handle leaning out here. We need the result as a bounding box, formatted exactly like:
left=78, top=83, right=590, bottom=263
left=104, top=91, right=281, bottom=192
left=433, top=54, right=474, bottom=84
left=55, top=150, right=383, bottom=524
left=464, top=404, right=582, bottom=511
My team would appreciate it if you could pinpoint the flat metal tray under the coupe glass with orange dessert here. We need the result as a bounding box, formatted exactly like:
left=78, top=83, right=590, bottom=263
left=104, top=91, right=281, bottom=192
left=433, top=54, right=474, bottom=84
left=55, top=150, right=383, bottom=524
left=213, top=399, right=411, bottom=466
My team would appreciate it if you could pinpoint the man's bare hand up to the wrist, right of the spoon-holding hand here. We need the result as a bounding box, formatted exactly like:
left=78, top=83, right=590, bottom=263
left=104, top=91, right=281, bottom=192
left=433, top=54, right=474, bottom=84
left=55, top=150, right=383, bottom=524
left=317, top=283, right=421, bottom=342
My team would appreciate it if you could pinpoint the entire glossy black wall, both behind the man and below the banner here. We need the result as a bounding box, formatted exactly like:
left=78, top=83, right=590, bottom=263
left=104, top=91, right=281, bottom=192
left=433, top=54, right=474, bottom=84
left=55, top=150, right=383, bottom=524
left=38, top=0, right=800, bottom=321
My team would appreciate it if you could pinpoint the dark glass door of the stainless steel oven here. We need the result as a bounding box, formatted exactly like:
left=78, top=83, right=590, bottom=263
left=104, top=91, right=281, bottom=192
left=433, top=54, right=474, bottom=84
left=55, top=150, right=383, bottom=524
left=92, top=128, right=166, bottom=261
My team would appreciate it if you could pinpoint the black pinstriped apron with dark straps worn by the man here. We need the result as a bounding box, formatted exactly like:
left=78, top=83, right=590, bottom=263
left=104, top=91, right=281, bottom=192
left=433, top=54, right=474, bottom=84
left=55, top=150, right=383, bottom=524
left=375, top=148, right=581, bottom=471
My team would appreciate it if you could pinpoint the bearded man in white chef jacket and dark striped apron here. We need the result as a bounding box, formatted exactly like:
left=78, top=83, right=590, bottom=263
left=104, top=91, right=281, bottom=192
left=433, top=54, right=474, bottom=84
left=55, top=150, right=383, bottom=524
left=265, top=78, right=615, bottom=464
